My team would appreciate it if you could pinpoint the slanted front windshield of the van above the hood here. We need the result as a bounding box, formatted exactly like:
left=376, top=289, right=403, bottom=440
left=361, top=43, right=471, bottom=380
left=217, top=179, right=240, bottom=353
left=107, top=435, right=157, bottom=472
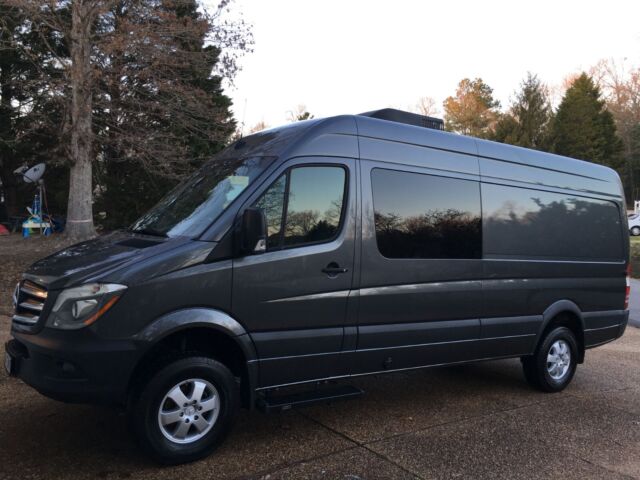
left=129, top=157, right=275, bottom=237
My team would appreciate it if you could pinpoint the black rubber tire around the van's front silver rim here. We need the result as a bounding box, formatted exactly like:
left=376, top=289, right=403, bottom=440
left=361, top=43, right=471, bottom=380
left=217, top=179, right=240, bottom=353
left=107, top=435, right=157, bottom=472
left=129, top=356, right=240, bottom=465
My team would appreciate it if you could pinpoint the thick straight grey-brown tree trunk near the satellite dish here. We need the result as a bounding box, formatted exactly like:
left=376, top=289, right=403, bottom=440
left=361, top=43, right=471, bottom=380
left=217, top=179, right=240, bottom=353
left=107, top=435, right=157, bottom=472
left=65, top=0, right=95, bottom=240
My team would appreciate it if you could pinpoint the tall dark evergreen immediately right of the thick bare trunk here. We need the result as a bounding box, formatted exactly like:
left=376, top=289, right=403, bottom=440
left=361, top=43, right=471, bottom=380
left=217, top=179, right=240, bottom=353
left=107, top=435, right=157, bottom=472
left=96, top=0, right=235, bottom=229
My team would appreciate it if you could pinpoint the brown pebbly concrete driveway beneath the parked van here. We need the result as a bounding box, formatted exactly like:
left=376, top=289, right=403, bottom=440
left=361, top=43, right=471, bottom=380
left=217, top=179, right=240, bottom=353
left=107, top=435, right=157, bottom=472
left=0, top=316, right=640, bottom=480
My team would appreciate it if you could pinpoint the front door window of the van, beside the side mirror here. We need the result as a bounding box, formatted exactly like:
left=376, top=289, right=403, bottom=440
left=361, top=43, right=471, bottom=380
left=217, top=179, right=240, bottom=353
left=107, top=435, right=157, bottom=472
left=255, top=166, right=346, bottom=250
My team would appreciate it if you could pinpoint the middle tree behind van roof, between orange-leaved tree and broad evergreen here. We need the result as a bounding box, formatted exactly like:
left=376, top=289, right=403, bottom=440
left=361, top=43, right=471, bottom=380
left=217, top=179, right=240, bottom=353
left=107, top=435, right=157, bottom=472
left=493, top=73, right=552, bottom=150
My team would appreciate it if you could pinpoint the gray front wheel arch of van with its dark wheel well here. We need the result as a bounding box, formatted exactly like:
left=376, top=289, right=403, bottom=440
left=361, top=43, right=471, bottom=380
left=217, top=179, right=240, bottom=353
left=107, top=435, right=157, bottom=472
left=127, top=308, right=258, bottom=408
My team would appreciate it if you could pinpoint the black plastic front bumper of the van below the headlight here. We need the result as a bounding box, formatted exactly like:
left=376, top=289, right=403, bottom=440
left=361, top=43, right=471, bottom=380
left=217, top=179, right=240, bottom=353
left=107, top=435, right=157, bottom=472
left=5, top=328, right=139, bottom=404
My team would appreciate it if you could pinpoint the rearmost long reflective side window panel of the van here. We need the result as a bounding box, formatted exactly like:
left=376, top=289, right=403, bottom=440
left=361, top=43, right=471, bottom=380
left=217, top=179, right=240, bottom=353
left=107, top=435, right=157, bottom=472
left=482, top=184, right=623, bottom=260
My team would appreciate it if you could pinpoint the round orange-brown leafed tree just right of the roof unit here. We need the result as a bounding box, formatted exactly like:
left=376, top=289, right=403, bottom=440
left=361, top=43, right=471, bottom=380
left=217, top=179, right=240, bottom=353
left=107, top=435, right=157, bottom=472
left=443, top=78, right=500, bottom=138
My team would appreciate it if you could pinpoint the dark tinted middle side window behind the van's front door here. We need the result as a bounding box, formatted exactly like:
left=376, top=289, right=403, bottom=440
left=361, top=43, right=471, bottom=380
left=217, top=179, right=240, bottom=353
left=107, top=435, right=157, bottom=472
left=371, top=169, right=482, bottom=258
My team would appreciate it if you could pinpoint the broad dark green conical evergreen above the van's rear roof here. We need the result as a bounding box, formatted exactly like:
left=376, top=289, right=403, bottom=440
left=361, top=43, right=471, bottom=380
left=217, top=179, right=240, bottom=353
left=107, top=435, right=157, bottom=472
left=552, top=73, right=622, bottom=168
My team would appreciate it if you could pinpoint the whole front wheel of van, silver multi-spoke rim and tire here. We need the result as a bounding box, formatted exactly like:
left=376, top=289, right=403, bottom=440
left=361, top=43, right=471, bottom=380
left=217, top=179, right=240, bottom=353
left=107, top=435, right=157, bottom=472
left=130, top=356, right=239, bottom=464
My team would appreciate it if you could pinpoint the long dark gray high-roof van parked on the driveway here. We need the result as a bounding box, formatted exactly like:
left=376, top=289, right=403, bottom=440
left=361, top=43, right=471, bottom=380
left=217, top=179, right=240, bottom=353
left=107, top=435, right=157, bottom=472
left=5, top=110, right=629, bottom=463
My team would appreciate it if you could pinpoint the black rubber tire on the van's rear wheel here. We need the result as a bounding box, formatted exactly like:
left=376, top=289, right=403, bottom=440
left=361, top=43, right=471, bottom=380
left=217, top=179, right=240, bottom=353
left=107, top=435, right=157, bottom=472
left=522, top=327, right=578, bottom=393
